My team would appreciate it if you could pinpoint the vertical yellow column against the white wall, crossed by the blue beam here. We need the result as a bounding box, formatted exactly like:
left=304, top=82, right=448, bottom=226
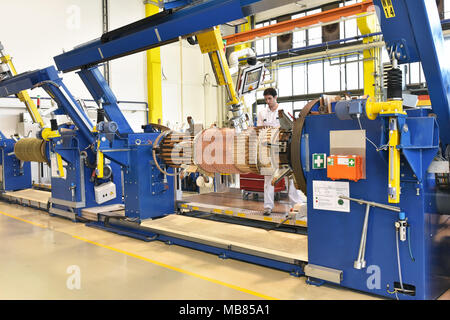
left=144, top=1, right=162, bottom=123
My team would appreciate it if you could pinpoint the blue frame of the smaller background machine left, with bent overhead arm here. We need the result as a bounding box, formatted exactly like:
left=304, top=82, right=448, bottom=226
left=0, top=67, right=122, bottom=220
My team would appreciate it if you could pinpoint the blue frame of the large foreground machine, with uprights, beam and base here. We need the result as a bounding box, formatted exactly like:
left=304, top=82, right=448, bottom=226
left=0, top=0, right=450, bottom=299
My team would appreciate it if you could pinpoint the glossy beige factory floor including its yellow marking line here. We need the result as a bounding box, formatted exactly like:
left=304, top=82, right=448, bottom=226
left=0, top=202, right=449, bottom=300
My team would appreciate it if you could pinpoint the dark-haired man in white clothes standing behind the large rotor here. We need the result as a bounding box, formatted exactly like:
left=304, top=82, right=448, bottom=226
left=257, top=88, right=306, bottom=215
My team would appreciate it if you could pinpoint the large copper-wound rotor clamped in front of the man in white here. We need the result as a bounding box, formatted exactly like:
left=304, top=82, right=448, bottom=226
left=159, top=127, right=290, bottom=175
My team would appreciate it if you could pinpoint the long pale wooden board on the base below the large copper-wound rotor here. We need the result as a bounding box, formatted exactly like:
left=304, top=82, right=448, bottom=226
left=141, top=215, right=308, bottom=263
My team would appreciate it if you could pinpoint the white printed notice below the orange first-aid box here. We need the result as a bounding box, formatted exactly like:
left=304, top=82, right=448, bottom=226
left=313, top=180, right=350, bottom=212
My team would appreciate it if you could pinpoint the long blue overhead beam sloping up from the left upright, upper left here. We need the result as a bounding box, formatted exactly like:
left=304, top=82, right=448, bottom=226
left=54, top=0, right=248, bottom=72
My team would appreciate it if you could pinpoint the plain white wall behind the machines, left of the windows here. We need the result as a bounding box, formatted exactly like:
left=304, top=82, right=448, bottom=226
left=0, top=0, right=222, bottom=134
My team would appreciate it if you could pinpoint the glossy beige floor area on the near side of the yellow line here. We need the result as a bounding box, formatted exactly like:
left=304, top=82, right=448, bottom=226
left=0, top=215, right=255, bottom=299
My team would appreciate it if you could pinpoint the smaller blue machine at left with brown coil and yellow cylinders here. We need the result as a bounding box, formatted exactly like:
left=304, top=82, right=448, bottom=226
left=0, top=67, right=122, bottom=221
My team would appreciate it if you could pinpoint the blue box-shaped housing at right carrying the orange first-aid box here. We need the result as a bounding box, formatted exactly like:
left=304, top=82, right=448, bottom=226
left=304, top=103, right=444, bottom=299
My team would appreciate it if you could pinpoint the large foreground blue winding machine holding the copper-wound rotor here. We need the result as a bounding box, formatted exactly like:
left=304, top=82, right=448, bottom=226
left=0, top=0, right=450, bottom=299
